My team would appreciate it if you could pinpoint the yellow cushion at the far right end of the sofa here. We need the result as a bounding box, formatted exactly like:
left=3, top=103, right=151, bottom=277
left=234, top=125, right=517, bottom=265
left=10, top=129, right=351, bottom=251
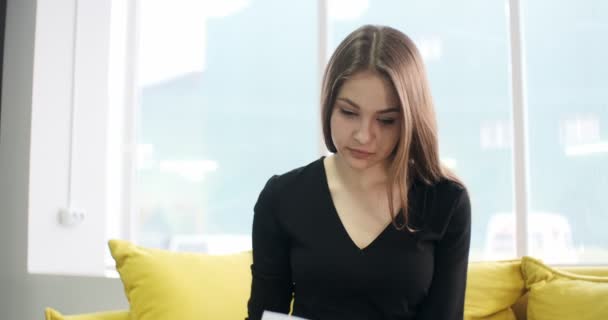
left=521, top=257, right=608, bottom=320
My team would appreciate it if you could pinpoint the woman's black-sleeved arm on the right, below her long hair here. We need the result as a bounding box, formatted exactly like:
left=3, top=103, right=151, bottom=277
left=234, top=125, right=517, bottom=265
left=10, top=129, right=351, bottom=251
left=416, top=188, right=471, bottom=320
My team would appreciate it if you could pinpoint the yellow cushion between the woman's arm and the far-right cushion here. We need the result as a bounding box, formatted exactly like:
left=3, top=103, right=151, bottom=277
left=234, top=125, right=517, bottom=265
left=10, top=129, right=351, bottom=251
left=464, top=260, right=524, bottom=320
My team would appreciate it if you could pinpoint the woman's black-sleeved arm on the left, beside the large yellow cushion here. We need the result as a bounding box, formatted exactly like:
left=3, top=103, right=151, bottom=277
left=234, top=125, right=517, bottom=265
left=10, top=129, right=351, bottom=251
left=247, top=176, right=293, bottom=320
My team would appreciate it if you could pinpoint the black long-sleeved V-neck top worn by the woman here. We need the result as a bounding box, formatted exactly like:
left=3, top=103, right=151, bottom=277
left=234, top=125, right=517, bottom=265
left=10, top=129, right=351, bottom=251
left=248, top=158, right=471, bottom=320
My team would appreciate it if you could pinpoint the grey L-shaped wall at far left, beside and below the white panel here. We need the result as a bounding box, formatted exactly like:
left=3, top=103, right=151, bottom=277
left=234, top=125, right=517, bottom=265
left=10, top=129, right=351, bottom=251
left=0, top=0, right=128, bottom=320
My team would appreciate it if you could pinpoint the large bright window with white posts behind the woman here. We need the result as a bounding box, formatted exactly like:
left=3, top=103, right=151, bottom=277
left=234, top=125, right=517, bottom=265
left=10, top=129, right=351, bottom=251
left=102, top=0, right=608, bottom=264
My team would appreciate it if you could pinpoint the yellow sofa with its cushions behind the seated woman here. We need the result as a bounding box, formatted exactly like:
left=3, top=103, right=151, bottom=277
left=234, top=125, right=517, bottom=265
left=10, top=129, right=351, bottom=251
left=45, top=240, right=608, bottom=320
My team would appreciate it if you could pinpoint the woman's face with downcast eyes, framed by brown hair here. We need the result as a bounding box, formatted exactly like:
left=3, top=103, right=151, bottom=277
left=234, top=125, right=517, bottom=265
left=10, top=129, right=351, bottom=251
left=330, top=71, right=402, bottom=170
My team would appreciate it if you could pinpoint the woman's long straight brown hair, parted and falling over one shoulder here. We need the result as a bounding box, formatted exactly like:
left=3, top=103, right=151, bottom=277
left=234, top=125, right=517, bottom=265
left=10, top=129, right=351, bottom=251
left=321, top=25, right=461, bottom=232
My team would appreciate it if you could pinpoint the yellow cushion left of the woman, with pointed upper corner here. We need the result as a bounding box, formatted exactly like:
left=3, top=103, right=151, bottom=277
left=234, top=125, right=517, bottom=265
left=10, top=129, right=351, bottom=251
left=109, top=240, right=252, bottom=320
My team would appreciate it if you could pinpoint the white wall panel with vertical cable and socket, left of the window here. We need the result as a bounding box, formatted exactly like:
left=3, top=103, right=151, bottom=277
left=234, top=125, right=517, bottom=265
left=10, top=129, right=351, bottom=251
left=27, top=0, right=110, bottom=275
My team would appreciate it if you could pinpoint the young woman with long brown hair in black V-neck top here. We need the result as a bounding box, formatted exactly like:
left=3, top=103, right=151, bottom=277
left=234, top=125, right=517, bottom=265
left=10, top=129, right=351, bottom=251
left=248, top=25, right=471, bottom=320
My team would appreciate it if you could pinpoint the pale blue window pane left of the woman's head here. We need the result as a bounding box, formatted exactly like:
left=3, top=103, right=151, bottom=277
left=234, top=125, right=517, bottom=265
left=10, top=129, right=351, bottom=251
left=136, top=1, right=320, bottom=247
